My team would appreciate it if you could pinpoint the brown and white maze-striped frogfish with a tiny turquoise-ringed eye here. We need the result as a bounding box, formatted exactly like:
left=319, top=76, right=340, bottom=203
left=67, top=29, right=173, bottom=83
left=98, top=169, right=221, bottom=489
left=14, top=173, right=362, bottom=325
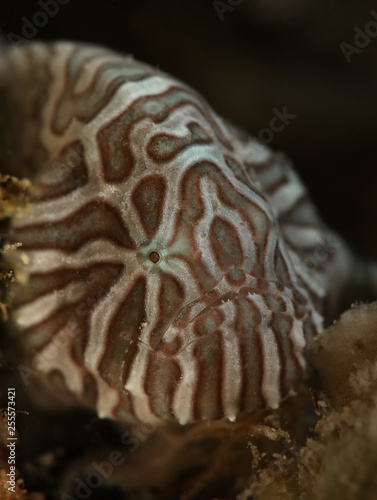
left=0, top=42, right=370, bottom=424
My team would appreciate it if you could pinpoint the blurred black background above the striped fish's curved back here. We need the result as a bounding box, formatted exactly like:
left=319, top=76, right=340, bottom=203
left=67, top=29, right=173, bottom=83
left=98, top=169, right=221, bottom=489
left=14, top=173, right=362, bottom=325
left=0, top=0, right=377, bottom=257
